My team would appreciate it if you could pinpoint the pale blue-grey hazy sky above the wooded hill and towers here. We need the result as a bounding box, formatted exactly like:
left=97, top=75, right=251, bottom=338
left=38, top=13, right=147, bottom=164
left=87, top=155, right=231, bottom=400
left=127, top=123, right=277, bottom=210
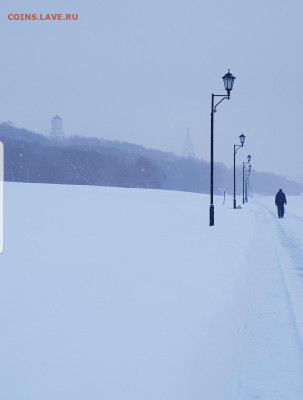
left=0, top=0, right=303, bottom=181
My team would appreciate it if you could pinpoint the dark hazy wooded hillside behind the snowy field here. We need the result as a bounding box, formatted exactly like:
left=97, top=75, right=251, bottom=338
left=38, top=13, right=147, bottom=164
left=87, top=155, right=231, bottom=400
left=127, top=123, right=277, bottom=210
left=0, top=123, right=303, bottom=195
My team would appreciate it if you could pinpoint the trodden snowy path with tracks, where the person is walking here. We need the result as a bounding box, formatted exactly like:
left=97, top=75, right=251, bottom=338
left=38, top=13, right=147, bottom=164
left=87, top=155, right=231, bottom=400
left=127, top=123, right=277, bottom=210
left=236, top=199, right=303, bottom=400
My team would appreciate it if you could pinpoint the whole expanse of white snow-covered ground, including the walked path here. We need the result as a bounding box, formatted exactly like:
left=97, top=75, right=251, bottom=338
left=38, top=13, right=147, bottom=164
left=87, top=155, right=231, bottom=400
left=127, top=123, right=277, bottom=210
left=0, top=183, right=303, bottom=400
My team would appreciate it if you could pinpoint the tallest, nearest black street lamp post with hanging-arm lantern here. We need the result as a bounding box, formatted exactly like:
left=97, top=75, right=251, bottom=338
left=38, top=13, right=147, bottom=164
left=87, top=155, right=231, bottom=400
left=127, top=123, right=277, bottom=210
left=209, top=70, right=236, bottom=226
